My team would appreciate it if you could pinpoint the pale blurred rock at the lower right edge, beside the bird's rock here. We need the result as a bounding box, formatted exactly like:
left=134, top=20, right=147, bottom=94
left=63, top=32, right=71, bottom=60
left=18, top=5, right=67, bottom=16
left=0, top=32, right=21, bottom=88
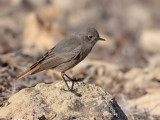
left=128, top=90, right=160, bottom=115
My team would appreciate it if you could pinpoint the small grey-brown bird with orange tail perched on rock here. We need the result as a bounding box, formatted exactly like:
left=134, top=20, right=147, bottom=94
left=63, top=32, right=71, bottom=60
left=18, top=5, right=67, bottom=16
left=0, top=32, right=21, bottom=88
left=16, top=28, right=104, bottom=93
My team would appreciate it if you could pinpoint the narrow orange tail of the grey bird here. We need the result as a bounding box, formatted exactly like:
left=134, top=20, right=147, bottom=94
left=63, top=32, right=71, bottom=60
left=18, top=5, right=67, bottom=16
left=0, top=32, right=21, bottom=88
left=15, top=64, right=40, bottom=81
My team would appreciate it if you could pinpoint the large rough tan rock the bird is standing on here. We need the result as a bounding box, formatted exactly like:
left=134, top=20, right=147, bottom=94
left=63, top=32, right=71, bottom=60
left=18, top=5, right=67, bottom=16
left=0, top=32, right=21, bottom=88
left=0, top=82, right=127, bottom=120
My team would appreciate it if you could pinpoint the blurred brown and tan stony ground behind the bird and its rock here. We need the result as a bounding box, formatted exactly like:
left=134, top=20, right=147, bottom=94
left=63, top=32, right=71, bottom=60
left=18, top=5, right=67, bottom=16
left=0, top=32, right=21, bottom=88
left=0, top=0, right=160, bottom=120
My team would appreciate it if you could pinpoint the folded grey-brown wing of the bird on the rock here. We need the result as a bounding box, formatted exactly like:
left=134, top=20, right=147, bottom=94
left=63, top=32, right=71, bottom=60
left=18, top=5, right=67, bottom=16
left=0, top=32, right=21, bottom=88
left=31, top=37, right=81, bottom=74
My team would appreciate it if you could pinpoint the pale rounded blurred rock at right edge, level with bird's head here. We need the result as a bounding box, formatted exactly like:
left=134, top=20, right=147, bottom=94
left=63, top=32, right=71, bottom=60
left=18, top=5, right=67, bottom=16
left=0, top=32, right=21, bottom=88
left=140, top=29, right=160, bottom=53
